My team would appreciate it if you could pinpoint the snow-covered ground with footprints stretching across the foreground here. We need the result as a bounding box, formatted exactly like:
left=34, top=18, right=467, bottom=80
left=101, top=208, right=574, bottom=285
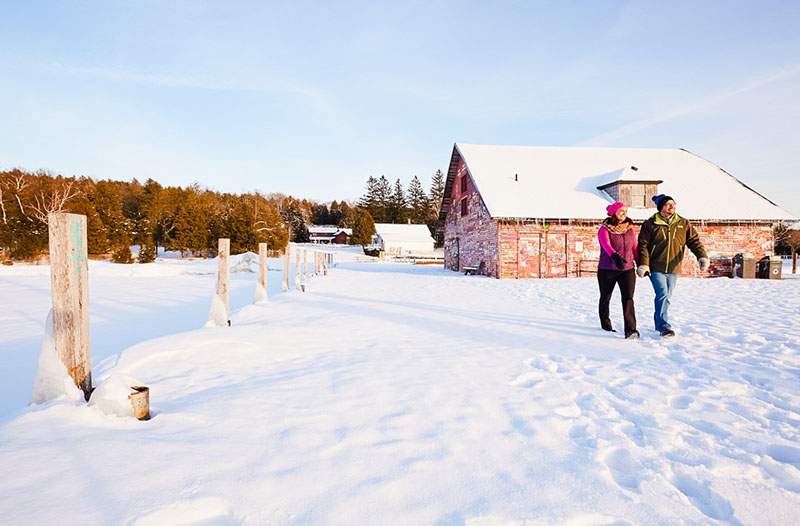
left=0, top=252, right=800, bottom=526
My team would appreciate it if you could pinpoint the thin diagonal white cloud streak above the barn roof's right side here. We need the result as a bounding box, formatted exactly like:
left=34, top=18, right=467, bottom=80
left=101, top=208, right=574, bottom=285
left=580, top=66, right=800, bottom=146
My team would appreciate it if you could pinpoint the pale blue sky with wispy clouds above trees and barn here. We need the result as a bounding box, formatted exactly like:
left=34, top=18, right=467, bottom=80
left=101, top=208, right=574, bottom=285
left=0, top=0, right=800, bottom=216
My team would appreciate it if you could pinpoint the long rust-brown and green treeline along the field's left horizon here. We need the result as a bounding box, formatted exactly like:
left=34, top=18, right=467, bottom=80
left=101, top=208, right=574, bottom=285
left=0, top=169, right=366, bottom=262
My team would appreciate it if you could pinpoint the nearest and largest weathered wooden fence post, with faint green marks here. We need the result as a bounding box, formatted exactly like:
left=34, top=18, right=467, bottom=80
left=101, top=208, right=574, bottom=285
left=47, top=213, right=92, bottom=400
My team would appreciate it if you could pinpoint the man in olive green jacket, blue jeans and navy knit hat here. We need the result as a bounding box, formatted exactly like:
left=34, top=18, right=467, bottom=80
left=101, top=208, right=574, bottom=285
left=636, top=194, right=709, bottom=338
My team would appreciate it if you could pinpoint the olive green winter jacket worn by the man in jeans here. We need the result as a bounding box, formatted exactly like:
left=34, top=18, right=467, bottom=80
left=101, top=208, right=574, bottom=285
left=638, top=213, right=707, bottom=274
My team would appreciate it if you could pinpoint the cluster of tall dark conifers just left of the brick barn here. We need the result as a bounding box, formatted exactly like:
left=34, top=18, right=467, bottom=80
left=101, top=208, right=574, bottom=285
left=358, top=170, right=444, bottom=235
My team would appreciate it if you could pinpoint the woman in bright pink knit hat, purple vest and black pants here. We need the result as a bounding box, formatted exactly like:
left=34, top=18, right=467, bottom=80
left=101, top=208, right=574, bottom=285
left=597, top=201, right=639, bottom=340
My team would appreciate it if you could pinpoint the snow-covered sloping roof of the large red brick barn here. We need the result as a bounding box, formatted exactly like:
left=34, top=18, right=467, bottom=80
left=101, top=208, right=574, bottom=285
left=440, top=143, right=796, bottom=221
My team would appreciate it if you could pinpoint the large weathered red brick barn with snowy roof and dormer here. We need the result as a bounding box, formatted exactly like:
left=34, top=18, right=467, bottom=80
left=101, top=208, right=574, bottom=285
left=439, top=144, right=796, bottom=278
